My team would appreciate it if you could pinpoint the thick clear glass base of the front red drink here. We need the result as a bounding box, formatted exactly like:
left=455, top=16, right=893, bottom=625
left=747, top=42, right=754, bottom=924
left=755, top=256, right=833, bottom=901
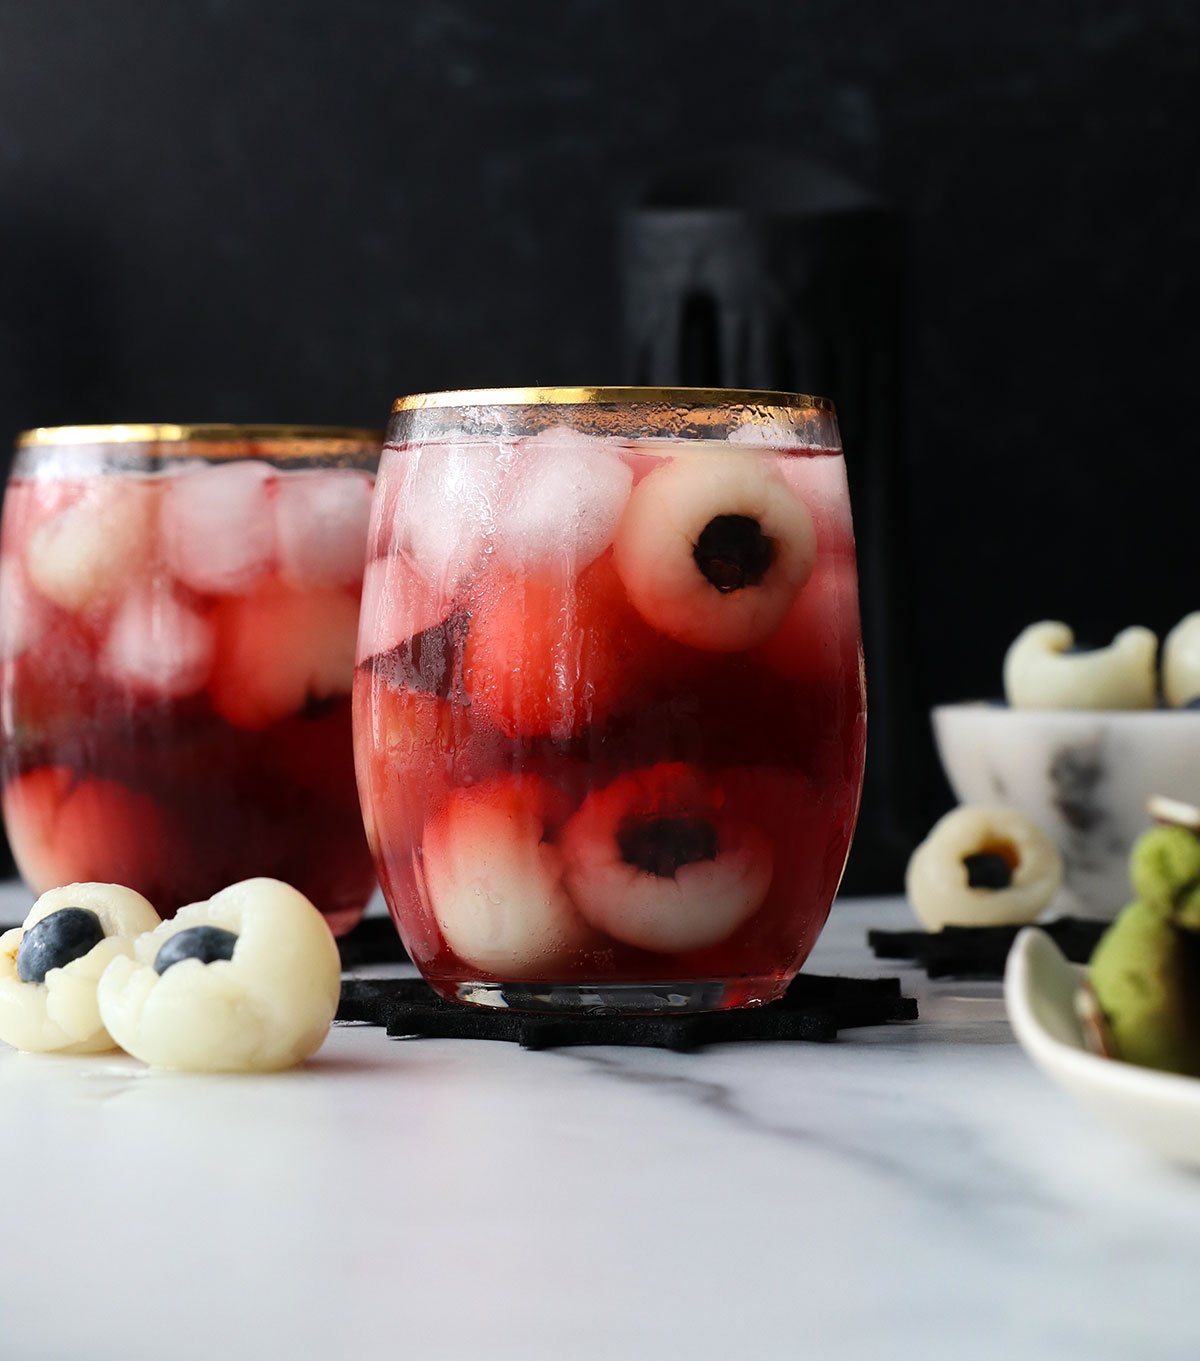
left=443, top=977, right=789, bottom=1017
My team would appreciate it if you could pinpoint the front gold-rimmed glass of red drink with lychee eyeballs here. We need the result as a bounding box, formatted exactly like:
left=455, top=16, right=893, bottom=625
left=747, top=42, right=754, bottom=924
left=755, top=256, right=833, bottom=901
left=354, top=388, right=865, bottom=1011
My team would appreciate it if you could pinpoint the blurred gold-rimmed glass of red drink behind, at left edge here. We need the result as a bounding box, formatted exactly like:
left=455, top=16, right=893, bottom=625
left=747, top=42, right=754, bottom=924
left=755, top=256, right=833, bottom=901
left=0, top=425, right=381, bottom=931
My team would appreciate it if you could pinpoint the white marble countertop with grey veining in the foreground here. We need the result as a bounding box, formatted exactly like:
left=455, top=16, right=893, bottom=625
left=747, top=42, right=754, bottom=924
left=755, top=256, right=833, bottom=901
left=0, top=890, right=1200, bottom=1361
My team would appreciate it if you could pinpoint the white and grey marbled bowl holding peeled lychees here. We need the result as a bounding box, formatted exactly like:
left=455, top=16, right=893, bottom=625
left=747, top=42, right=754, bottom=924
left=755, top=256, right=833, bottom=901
left=933, top=704, right=1200, bottom=917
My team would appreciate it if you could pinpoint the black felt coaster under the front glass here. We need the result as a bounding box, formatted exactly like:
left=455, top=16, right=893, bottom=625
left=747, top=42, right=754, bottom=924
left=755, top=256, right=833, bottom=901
left=337, top=974, right=917, bottom=1051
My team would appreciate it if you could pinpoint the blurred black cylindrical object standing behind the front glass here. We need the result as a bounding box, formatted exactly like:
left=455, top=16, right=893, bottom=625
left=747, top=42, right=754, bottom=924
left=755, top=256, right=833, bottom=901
left=620, top=154, right=932, bottom=891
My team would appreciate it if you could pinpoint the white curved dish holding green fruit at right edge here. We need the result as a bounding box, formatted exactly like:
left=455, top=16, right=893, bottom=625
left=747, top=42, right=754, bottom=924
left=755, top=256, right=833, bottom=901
left=1004, top=927, right=1200, bottom=1168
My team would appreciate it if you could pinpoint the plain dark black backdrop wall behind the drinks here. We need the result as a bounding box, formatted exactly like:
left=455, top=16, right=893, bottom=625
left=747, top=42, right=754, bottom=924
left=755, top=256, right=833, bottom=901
left=0, top=0, right=1200, bottom=871
